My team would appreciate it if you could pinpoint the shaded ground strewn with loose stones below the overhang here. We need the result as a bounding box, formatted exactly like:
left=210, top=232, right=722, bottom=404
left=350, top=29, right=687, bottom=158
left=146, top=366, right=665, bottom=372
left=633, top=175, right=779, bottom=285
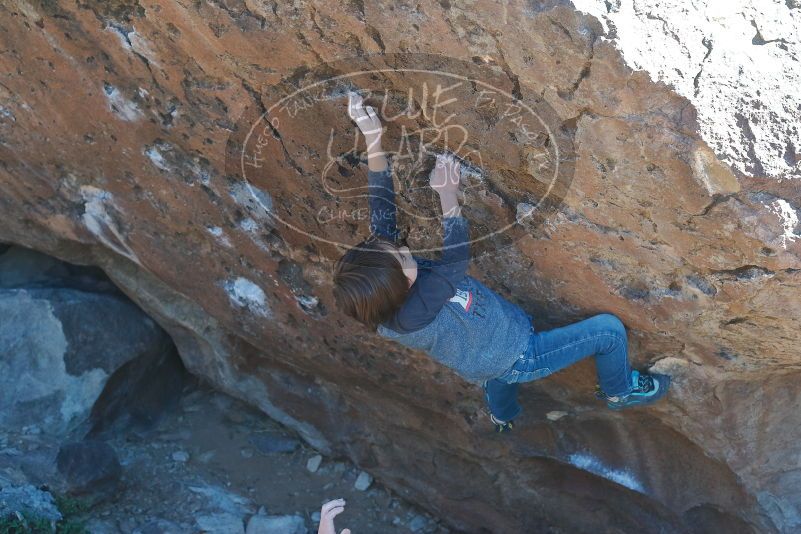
left=0, top=386, right=448, bottom=534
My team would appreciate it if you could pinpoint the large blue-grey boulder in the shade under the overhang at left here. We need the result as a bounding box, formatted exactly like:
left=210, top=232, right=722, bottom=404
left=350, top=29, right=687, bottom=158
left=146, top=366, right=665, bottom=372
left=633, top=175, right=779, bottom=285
left=0, top=247, right=186, bottom=437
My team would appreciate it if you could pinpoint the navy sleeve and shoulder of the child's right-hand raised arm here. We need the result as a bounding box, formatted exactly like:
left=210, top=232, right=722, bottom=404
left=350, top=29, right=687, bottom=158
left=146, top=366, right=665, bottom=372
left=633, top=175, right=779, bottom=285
left=388, top=217, right=470, bottom=332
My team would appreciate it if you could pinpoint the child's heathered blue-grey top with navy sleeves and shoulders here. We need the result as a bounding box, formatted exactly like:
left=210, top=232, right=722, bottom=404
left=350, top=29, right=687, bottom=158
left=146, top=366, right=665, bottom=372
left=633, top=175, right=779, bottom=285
left=368, top=169, right=531, bottom=384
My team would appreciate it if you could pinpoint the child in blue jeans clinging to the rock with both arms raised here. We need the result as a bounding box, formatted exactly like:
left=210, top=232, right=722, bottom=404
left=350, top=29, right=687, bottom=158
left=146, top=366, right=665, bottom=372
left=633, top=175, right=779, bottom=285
left=334, top=93, right=670, bottom=432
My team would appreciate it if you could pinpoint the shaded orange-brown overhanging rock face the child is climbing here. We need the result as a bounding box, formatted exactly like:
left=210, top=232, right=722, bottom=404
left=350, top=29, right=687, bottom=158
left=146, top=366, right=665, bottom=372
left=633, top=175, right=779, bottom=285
left=0, top=0, right=801, bottom=532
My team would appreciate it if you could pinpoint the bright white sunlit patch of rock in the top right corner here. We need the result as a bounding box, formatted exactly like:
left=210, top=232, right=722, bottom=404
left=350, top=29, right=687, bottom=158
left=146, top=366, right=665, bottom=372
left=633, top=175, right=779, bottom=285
left=574, top=0, right=801, bottom=179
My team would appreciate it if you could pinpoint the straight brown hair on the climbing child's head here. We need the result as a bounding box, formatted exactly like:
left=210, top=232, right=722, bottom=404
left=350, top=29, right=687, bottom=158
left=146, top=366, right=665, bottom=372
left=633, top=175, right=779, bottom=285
left=334, top=236, right=409, bottom=330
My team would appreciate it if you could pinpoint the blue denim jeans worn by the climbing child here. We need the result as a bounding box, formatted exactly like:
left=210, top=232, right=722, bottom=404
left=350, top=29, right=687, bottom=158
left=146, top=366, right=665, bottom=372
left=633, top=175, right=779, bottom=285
left=484, top=313, right=632, bottom=421
